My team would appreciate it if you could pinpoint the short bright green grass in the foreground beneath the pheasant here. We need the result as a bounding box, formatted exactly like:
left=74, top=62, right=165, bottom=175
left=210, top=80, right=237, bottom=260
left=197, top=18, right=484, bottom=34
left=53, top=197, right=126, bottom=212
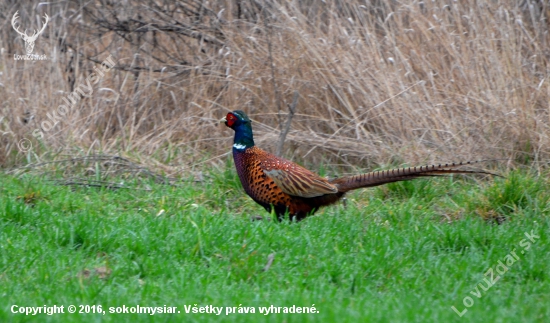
left=0, top=171, right=550, bottom=322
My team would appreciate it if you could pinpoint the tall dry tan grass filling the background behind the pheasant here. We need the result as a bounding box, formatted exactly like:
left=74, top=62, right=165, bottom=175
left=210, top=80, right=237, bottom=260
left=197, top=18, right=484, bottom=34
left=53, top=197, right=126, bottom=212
left=0, top=0, right=550, bottom=173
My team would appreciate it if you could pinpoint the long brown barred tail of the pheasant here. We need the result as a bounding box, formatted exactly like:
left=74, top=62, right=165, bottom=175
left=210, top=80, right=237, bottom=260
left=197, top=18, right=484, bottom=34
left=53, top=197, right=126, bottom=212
left=330, top=161, right=500, bottom=193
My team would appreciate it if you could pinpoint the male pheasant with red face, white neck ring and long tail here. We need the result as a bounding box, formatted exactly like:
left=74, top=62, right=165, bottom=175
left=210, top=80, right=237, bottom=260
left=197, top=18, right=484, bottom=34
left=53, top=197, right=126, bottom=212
left=220, top=110, right=494, bottom=221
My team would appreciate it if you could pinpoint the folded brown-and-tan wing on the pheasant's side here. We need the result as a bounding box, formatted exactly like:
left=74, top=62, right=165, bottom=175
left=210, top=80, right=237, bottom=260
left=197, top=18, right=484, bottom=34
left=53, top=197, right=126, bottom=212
left=260, top=154, right=338, bottom=197
